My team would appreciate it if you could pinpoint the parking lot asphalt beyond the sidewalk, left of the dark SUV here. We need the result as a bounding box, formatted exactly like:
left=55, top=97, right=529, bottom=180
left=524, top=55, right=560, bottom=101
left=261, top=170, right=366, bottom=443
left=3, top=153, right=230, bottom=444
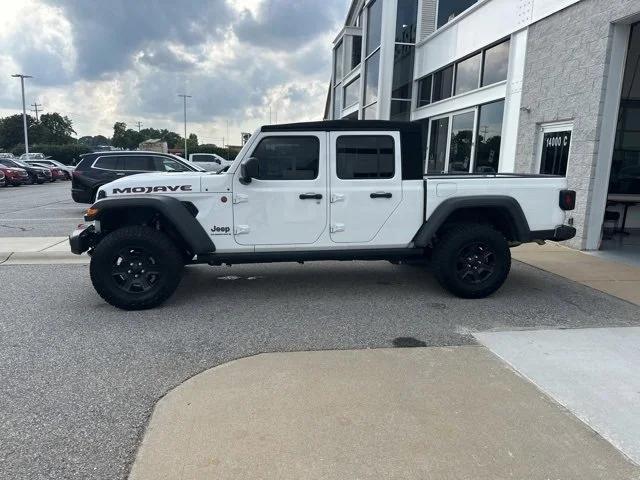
left=0, top=181, right=87, bottom=237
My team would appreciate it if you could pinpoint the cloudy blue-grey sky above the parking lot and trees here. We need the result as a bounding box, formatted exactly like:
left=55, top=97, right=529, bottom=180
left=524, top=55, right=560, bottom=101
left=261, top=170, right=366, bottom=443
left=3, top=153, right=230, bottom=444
left=0, top=0, right=350, bottom=144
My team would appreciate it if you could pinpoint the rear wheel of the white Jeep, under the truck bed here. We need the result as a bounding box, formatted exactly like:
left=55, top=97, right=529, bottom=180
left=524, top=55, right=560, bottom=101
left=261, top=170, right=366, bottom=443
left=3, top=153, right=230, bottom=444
left=433, top=224, right=511, bottom=298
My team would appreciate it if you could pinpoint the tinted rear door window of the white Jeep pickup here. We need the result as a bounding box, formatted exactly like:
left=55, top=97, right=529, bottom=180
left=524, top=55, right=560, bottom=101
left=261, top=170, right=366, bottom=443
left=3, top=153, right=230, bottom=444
left=336, top=135, right=395, bottom=180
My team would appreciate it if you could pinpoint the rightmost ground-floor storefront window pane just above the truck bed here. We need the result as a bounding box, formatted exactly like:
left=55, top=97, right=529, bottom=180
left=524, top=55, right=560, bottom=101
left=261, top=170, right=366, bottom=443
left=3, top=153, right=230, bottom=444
left=475, top=100, right=504, bottom=173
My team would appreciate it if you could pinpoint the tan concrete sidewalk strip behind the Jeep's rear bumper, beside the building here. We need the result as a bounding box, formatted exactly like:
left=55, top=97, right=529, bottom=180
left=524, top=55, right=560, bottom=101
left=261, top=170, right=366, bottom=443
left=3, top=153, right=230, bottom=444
left=511, top=243, right=640, bottom=305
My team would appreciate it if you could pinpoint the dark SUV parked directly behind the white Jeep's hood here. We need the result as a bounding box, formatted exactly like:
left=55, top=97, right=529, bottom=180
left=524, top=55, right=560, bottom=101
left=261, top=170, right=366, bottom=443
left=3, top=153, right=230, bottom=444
left=71, top=151, right=203, bottom=203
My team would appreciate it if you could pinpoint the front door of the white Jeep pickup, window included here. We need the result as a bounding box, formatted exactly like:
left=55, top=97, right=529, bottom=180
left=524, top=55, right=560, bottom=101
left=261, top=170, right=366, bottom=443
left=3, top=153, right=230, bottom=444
left=233, top=132, right=328, bottom=246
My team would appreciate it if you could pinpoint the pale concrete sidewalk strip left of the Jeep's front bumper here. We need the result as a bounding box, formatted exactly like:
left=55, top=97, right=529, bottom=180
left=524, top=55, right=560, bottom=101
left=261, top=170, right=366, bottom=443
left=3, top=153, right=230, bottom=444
left=0, top=237, right=89, bottom=265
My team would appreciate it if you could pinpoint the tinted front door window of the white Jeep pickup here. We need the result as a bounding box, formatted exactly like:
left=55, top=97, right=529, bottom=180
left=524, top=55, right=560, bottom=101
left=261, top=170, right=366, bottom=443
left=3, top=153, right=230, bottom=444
left=252, top=136, right=320, bottom=180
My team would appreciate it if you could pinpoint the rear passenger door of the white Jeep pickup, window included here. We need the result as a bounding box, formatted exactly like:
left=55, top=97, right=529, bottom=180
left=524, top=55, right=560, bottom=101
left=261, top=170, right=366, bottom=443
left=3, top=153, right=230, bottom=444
left=329, top=132, right=402, bottom=243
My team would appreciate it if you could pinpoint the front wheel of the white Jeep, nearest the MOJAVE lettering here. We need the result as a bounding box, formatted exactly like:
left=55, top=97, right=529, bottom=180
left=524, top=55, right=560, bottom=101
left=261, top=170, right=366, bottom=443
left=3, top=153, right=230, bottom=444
left=89, top=226, right=184, bottom=310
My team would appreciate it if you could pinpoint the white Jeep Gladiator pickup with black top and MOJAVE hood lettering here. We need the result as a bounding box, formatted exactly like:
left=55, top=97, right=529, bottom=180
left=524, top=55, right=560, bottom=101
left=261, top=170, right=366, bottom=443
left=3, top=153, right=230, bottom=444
left=70, top=120, right=575, bottom=309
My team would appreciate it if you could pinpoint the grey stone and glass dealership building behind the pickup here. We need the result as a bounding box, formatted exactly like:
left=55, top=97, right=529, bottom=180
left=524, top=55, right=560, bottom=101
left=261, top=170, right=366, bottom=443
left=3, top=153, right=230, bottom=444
left=325, top=0, right=640, bottom=252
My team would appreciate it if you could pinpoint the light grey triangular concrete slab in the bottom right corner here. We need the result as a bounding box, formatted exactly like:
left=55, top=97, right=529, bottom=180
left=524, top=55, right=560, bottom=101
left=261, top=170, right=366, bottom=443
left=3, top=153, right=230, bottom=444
left=475, top=328, right=640, bottom=464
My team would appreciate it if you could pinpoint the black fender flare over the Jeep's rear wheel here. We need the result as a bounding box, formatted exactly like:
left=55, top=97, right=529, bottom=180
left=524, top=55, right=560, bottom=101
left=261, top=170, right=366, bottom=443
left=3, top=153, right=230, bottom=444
left=413, top=195, right=531, bottom=248
